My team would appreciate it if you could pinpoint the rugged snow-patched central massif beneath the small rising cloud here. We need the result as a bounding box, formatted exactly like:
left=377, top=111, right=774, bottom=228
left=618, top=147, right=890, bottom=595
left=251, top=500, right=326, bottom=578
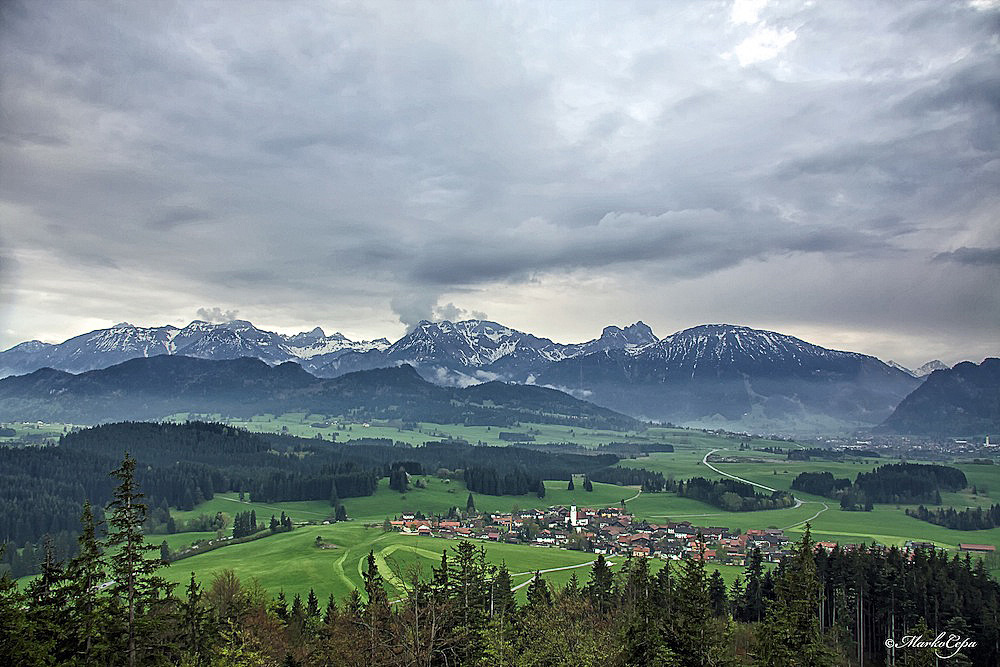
left=318, top=320, right=657, bottom=384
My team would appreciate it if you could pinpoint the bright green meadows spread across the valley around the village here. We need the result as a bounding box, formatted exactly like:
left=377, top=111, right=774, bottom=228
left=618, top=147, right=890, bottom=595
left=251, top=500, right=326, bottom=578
left=99, top=414, right=1000, bottom=598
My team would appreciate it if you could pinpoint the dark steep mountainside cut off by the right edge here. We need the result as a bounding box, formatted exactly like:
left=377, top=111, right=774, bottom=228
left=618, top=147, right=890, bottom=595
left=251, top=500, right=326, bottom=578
left=879, top=358, right=1000, bottom=436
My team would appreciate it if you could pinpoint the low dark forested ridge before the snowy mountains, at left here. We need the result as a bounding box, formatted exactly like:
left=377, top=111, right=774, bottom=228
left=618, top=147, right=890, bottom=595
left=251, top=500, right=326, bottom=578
left=0, top=354, right=636, bottom=429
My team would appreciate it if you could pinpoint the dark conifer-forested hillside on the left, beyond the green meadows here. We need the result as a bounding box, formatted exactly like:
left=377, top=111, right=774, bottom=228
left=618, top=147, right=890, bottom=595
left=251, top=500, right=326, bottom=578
left=0, top=422, right=620, bottom=567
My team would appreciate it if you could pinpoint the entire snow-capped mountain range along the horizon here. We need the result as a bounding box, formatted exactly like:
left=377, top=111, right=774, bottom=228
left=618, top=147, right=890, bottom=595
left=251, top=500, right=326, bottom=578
left=0, top=320, right=960, bottom=433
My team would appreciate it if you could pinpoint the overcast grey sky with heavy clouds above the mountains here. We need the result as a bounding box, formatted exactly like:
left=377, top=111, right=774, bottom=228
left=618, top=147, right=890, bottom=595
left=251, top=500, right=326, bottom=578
left=0, top=0, right=1000, bottom=366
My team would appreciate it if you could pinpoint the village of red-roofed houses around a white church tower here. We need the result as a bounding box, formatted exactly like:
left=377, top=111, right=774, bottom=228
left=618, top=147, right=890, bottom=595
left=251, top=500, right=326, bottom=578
left=389, top=505, right=792, bottom=565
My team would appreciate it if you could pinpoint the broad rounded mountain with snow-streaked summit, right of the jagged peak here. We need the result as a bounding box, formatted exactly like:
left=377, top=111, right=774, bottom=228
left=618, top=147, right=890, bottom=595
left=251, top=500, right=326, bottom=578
left=537, top=324, right=920, bottom=431
